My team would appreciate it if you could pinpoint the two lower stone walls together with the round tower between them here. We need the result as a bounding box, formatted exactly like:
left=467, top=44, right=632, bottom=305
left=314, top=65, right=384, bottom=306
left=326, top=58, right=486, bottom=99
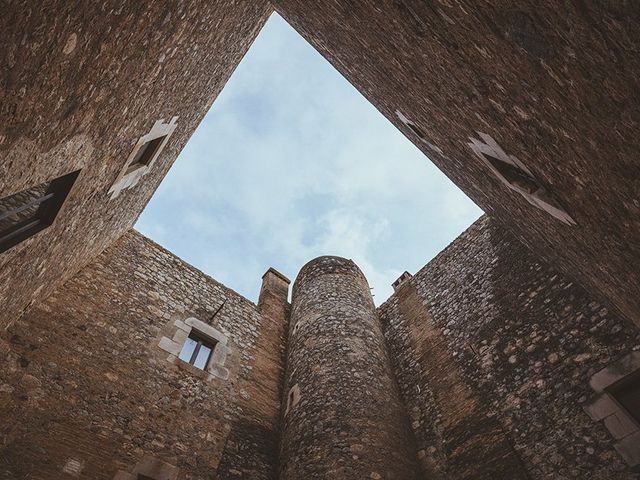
left=0, top=218, right=640, bottom=480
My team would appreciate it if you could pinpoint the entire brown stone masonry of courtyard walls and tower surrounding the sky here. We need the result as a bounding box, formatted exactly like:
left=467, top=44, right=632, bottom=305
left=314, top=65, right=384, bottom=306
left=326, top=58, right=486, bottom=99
left=0, top=0, right=640, bottom=480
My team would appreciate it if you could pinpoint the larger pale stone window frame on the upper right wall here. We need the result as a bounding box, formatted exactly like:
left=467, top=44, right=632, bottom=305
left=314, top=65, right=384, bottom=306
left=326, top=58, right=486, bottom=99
left=467, top=132, right=576, bottom=225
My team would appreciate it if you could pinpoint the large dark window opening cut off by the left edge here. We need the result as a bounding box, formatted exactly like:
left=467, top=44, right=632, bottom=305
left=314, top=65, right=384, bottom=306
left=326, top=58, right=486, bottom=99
left=0, top=170, right=80, bottom=253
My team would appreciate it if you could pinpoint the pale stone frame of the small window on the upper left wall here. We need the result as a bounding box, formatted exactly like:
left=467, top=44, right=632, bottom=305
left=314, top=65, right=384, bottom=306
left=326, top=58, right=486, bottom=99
left=109, top=117, right=178, bottom=200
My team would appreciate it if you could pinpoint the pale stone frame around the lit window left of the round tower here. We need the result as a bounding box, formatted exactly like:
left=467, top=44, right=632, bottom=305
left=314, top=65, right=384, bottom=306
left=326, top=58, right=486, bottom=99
left=158, top=317, right=231, bottom=381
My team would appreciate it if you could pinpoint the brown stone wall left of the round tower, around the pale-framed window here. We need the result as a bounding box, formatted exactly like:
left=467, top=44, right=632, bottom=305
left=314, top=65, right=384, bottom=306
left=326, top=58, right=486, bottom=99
left=0, top=231, right=286, bottom=480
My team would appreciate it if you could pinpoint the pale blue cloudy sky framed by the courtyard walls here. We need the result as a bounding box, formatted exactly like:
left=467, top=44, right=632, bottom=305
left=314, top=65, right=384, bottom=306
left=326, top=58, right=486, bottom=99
left=136, top=14, right=482, bottom=304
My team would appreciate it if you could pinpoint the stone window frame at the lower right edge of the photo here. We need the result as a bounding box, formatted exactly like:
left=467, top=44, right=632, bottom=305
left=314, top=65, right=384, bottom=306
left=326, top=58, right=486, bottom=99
left=583, top=351, right=640, bottom=472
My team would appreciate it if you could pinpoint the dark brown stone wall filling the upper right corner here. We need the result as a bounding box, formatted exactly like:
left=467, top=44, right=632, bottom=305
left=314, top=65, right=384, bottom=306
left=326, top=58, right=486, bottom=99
left=273, top=0, right=640, bottom=322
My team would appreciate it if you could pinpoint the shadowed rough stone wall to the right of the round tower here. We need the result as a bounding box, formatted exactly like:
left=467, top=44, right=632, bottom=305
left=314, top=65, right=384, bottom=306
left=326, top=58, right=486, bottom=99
left=378, top=217, right=640, bottom=480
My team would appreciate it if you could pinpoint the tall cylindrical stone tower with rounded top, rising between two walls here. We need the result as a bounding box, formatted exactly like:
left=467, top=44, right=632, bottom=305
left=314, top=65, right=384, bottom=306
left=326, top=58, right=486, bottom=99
left=280, top=257, right=417, bottom=480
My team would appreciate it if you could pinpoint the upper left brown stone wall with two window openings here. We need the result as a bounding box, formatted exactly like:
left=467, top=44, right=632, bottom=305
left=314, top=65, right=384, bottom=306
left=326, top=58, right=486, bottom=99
left=0, top=0, right=271, bottom=329
